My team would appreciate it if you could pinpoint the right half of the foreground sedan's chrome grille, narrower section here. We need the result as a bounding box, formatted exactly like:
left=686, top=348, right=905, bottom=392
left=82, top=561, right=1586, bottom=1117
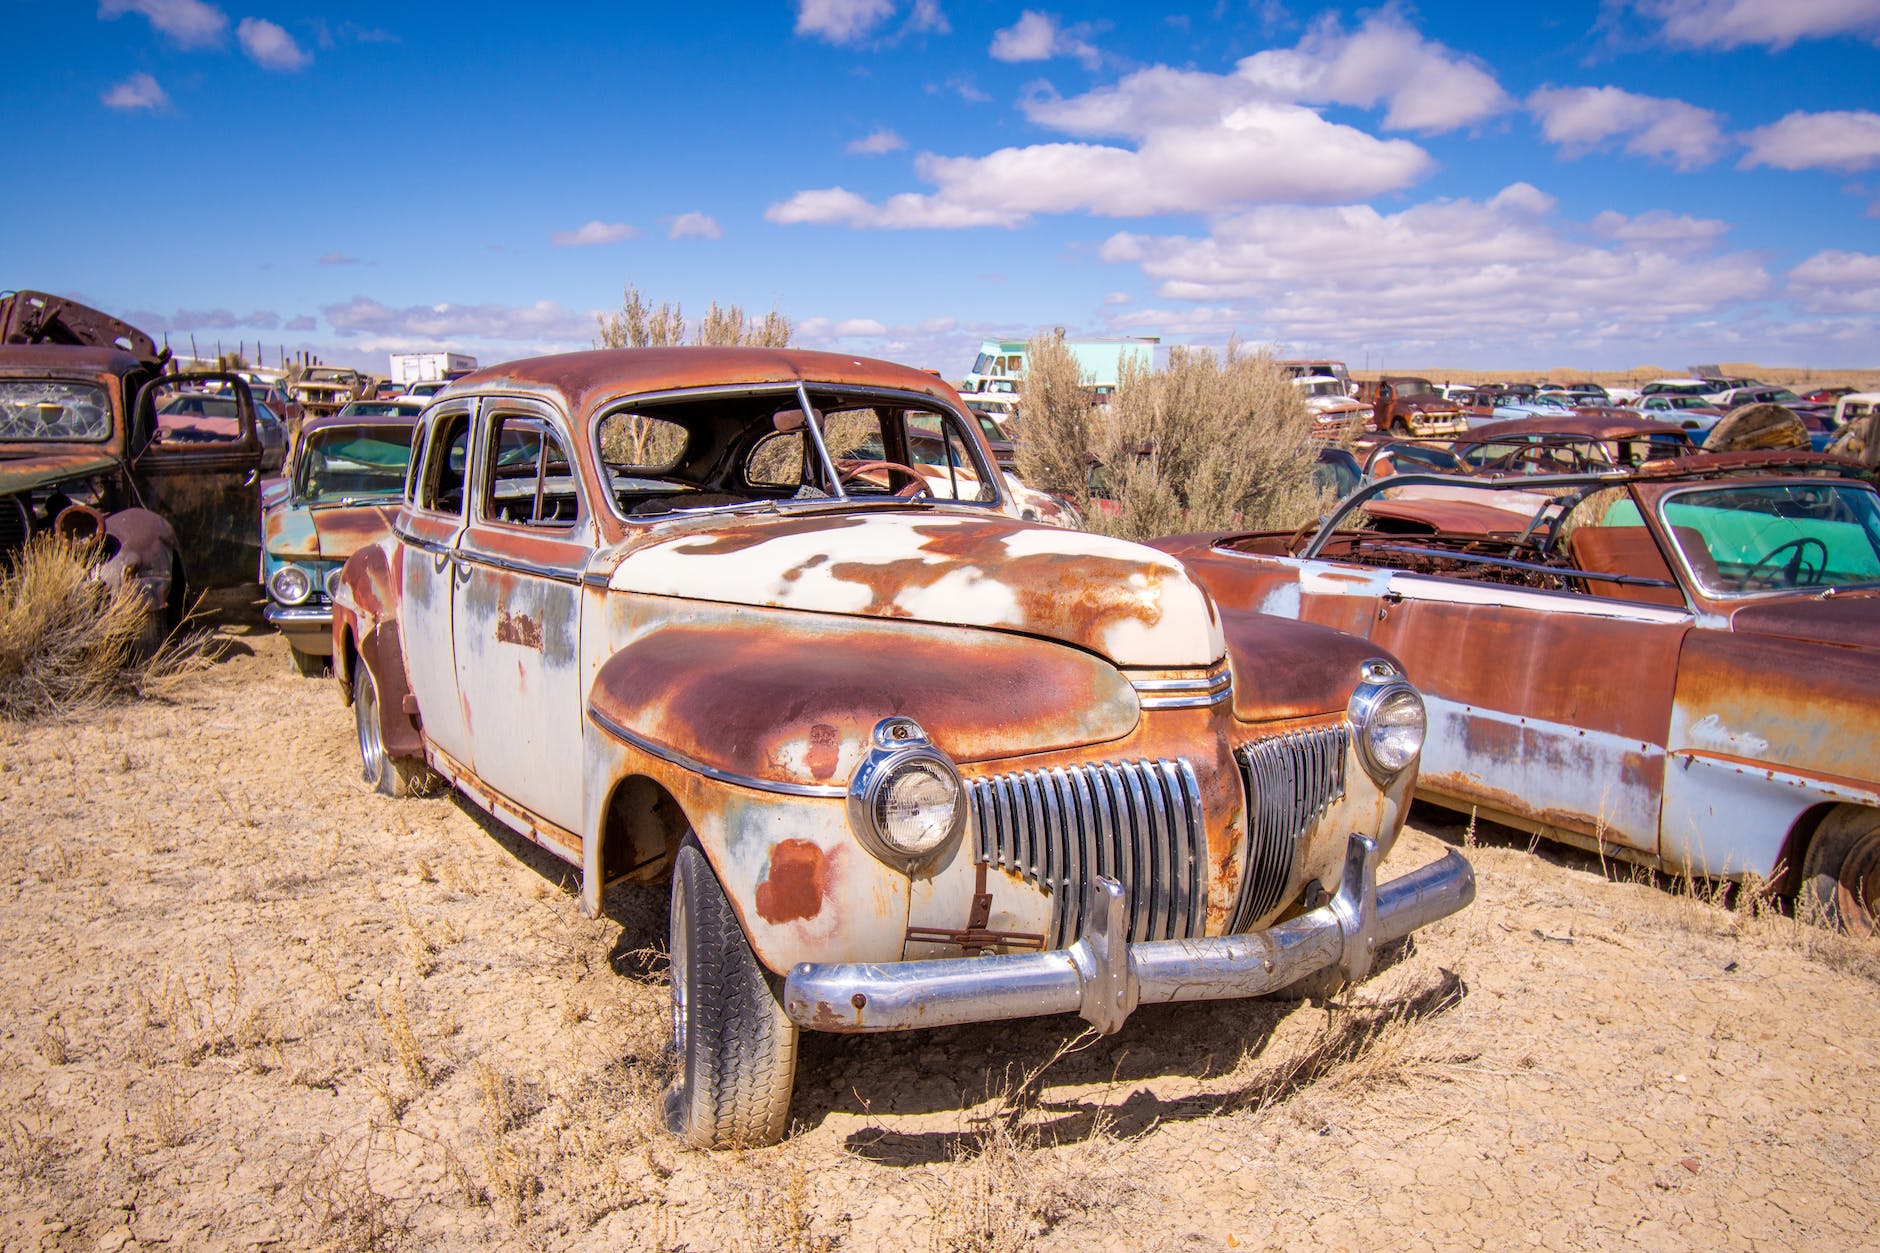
left=1233, top=724, right=1352, bottom=931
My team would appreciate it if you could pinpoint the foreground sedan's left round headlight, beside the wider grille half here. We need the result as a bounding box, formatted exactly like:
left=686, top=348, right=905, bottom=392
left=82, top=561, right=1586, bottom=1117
left=848, top=719, right=966, bottom=871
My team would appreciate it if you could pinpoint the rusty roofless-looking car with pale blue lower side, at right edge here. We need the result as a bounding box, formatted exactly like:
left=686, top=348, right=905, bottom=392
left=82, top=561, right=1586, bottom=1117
left=1156, top=453, right=1880, bottom=931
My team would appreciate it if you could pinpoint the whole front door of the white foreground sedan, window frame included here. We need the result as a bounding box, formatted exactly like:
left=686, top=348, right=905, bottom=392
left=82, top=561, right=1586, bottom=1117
left=451, top=397, right=594, bottom=832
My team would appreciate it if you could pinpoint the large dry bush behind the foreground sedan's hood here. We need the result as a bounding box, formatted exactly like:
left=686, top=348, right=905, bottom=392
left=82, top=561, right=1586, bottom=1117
left=1019, top=337, right=1322, bottom=540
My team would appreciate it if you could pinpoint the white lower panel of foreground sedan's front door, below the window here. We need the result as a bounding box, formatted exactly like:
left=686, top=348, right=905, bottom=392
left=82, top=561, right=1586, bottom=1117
left=451, top=523, right=592, bottom=830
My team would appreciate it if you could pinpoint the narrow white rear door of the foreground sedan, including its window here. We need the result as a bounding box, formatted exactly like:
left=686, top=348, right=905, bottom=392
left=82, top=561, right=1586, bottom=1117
left=393, top=401, right=476, bottom=762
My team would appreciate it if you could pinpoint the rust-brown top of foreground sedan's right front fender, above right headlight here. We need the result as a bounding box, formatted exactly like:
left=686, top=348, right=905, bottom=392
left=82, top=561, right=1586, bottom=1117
left=1220, top=608, right=1416, bottom=722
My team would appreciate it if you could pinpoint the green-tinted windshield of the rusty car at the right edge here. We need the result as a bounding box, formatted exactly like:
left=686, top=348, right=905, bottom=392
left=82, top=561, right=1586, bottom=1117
left=1662, top=484, right=1880, bottom=596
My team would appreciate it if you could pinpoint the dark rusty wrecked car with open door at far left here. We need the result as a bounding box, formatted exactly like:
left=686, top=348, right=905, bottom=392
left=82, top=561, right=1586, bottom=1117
left=0, top=292, right=267, bottom=634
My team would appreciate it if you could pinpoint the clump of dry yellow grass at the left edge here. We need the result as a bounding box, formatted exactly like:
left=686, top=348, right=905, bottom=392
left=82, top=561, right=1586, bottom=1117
left=0, top=534, right=152, bottom=721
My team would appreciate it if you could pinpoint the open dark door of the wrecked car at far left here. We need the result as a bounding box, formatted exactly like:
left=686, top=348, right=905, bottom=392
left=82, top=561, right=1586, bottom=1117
left=132, top=373, right=263, bottom=589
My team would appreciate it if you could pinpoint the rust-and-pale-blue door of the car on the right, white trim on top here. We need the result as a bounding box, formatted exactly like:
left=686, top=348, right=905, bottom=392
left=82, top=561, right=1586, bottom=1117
left=1371, top=576, right=1690, bottom=850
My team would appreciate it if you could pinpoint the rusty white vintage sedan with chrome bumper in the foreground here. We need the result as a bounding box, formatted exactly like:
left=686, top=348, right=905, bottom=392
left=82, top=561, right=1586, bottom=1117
left=333, top=348, right=1474, bottom=1146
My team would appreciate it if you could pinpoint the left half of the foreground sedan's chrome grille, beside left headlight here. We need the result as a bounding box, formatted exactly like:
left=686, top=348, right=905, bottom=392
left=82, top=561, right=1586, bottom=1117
left=966, top=760, right=1207, bottom=948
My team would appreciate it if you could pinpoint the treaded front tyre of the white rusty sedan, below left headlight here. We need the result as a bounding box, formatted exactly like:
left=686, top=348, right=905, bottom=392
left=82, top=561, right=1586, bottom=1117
left=666, top=837, right=797, bottom=1148
